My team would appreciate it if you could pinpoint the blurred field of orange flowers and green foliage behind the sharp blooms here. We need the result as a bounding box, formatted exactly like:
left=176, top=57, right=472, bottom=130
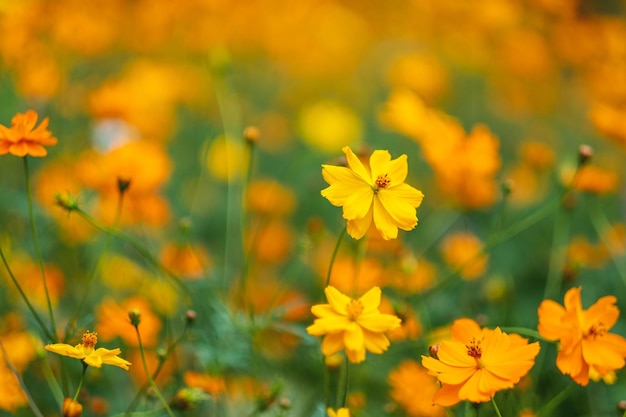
left=0, top=0, right=626, bottom=417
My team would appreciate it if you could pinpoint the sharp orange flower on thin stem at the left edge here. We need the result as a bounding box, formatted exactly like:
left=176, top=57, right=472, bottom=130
left=0, top=110, right=57, bottom=156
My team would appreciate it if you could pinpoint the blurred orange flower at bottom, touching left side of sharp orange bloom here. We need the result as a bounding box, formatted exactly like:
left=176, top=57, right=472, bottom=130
left=387, top=360, right=446, bottom=417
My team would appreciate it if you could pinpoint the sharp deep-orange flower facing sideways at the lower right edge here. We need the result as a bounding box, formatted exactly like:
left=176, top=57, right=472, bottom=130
left=537, top=287, right=626, bottom=386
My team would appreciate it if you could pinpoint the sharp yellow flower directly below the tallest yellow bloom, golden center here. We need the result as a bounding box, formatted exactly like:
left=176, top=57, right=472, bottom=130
left=306, top=286, right=401, bottom=363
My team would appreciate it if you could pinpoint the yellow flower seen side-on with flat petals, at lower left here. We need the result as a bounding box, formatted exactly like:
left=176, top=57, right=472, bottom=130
left=46, top=331, right=131, bottom=370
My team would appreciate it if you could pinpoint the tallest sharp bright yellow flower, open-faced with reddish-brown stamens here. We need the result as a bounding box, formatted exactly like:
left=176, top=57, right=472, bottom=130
left=322, top=146, right=424, bottom=240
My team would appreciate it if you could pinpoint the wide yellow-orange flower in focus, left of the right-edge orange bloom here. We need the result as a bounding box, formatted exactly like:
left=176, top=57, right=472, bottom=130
left=422, top=319, right=539, bottom=407
